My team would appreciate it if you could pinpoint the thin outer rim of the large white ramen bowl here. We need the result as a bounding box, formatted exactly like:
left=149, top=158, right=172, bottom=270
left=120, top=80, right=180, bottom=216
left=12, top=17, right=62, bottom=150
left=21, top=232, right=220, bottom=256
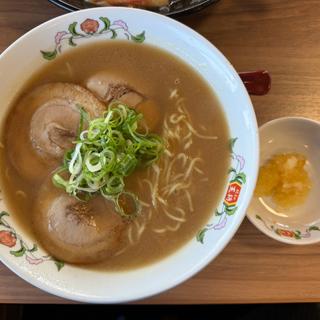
left=0, top=7, right=259, bottom=303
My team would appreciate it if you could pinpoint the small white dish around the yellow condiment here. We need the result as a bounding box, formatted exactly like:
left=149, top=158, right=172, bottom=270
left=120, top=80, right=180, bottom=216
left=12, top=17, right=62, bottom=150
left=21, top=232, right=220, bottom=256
left=247, top=117, right=320, bottom=245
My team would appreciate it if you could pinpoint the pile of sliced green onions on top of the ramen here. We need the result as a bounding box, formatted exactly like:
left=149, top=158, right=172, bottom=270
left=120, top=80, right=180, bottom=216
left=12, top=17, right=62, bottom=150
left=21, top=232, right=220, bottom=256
left=52, top=102, right=164, bottom=218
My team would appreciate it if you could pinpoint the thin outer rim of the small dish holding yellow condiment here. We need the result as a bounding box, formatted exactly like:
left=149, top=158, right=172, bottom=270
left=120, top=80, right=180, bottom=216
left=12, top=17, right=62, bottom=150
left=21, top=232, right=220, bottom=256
left=246, top=116, right=320, bottom=246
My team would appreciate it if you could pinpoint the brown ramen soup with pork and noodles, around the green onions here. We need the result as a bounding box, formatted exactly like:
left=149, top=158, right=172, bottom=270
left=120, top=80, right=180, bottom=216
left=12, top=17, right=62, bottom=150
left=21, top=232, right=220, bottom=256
left=1, top=40, right=230, bottom=270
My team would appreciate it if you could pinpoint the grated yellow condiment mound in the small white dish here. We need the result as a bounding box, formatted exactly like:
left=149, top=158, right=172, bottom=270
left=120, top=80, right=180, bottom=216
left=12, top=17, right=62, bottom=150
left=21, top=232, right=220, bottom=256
left=255, top=153, right=311, bottom=208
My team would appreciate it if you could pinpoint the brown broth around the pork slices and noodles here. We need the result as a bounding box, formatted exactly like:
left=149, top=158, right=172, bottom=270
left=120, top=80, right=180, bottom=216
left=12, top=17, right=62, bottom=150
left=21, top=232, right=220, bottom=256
left=1, top=40, right=230, bottom=270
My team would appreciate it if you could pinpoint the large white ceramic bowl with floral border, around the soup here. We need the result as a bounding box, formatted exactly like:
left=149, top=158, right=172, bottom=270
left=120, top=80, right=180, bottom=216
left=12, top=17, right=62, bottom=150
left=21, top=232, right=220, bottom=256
left=0, top=8, right=259, bottom=303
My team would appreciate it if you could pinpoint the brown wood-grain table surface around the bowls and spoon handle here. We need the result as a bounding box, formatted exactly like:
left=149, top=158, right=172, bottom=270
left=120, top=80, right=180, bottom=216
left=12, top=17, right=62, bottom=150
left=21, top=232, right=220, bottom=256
left=0, top=0, right=320, bottom=304
